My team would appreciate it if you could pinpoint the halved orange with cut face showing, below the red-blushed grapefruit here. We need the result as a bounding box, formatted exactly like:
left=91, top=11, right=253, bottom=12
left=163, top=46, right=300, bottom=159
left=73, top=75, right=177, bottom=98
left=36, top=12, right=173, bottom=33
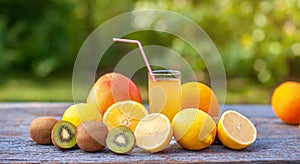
left=103, top=100, right=148, bottom=132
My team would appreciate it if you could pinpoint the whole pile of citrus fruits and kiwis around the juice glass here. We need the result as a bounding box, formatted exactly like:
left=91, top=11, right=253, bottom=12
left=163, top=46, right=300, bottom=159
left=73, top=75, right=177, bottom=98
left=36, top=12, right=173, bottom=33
left=29, top=73, right=256, bottom=154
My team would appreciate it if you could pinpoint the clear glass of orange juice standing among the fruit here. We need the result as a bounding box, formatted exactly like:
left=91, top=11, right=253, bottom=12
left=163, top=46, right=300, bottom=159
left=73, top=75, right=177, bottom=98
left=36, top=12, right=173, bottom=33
left=148, top=70, right=181, bottom=121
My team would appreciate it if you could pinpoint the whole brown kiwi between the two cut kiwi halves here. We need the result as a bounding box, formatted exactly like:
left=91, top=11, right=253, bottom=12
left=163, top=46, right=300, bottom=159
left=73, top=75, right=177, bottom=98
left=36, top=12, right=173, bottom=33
left=76, top=121, right=108, bottom=152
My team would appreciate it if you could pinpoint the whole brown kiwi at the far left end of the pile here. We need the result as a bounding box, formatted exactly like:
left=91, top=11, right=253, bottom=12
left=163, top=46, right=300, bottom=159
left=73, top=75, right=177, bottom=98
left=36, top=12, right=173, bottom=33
left=29, top=117, right=58, bottom=145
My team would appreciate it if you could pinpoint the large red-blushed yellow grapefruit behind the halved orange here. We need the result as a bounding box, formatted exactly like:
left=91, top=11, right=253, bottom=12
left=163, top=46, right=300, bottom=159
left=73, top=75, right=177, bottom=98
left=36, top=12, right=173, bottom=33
left=87, top=72, right=142, bottom=114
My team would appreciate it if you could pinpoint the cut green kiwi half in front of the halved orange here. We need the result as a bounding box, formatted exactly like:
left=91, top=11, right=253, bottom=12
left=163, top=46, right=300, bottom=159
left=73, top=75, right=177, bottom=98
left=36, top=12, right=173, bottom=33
left=106, top=126, right=136, bottom=154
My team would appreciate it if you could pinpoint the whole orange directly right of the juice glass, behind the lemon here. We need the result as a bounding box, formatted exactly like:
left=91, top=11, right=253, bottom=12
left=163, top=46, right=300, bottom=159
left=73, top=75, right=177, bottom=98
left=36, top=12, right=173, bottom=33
left=181, top=82, right=219, bottom=117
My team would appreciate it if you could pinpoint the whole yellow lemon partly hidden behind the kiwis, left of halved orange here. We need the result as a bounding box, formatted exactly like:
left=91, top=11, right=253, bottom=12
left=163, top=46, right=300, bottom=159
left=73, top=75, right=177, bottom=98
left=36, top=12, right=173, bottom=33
left=62, top=103, right=102, bottom=127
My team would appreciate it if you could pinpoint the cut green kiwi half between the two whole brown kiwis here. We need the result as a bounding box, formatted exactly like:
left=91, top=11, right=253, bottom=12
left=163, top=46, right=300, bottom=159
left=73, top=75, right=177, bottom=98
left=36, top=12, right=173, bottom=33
left=51, top=121, right=76, bottom=149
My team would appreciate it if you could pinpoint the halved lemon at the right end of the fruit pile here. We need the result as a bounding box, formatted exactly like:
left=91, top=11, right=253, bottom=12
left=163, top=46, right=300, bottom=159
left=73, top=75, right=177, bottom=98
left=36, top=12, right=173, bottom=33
left=218, top=110, right=256, bottom=150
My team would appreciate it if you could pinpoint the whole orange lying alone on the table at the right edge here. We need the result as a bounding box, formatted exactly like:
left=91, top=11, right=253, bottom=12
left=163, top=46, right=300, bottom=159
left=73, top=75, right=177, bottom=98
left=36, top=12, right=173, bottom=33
left=272, top=81, right=300, bottom=125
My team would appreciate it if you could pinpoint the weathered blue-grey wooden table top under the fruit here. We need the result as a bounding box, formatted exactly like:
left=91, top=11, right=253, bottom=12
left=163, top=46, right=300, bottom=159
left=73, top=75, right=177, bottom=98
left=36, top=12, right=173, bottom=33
left=0, top=103, right=300, bottom=163
